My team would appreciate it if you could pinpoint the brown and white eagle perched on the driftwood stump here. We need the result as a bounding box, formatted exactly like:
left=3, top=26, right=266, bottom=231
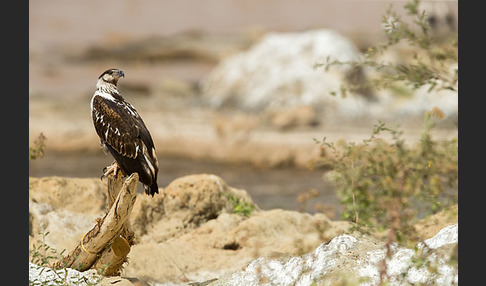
left=91, top=68, right=159, bottom=197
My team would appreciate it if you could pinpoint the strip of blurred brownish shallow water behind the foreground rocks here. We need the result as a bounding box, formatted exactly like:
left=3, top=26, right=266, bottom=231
left=29, top=151, right=340, bottom=218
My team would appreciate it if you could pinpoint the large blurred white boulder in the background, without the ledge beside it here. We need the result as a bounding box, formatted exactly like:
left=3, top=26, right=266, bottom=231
left=198, top=29, right=361, bottom=110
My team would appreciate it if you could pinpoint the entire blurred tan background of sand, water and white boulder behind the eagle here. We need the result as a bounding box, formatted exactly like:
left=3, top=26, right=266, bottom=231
left=29, top=0, right=458, bottom=216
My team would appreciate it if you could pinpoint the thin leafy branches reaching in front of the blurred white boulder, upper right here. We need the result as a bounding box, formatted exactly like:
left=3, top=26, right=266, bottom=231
left=314, top=0, right=459, bottom=97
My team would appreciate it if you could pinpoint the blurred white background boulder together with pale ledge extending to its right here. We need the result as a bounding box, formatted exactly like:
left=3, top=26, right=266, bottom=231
left=201, top=29, right=458, bottom=127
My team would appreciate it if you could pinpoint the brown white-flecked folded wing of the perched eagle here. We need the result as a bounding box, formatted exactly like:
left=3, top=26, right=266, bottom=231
left=92, top=96, right=154, bottom=158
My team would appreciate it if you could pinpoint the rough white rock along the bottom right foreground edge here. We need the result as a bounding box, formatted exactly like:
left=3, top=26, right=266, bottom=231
left=210, top=224, right=458, bottom=286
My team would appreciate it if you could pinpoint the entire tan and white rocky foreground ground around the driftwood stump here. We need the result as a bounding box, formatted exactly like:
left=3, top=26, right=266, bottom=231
left=29, top=174, right=457, bottom=285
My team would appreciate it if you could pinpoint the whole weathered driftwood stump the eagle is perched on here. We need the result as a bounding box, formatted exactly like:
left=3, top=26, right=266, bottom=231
left=54, top=170, right=138, bottom=276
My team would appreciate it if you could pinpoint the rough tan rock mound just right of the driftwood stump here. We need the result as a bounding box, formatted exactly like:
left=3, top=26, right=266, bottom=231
left=131, top=174, right=259, bottom=242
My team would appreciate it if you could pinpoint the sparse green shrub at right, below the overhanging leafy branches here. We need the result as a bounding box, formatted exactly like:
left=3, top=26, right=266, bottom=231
left=316, top=113, right=458, bottom=242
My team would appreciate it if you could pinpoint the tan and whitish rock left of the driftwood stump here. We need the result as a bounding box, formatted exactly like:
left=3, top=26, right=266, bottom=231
left=29, top=177, right=106, bottom=252
